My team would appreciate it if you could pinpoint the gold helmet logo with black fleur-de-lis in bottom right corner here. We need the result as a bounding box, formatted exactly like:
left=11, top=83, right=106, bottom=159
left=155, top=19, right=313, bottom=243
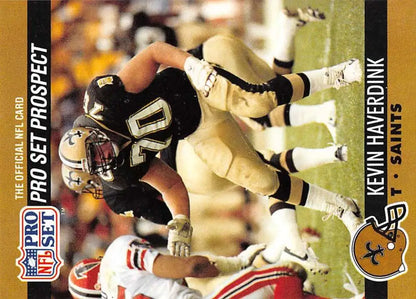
left=350, top=202, right=408, bottom=281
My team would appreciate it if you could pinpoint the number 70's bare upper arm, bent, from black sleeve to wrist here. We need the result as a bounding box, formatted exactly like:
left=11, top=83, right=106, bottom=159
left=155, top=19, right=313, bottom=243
left=117, top=42, right=191, bottom=93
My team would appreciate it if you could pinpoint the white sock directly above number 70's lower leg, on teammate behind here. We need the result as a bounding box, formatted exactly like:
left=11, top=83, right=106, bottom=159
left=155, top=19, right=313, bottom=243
left=292, top=146, right=338, bottom=171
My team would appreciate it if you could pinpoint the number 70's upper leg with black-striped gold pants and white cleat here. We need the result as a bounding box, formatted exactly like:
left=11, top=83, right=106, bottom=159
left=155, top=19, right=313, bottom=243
left=198, top=59, right=361, bottom=118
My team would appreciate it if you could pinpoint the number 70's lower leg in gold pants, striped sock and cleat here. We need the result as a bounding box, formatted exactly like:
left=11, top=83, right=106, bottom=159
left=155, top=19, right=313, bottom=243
left=187, top=101, right=361, bottom=239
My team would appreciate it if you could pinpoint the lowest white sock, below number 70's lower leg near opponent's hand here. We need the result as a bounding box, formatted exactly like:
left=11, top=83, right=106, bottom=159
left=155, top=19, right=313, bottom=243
left=262, top=209, right=306, bottom=263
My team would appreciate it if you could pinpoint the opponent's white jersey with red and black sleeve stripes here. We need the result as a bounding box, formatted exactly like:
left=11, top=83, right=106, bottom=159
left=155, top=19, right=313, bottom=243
left=99, top=236, right=202, bottom=299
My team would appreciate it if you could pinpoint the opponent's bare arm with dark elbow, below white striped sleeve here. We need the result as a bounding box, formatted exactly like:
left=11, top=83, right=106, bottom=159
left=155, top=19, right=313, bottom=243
left=153, top=254, right=219, bottom=279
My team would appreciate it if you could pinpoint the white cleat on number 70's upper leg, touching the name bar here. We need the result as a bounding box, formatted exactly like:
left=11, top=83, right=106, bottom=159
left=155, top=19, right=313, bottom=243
left=324, top=58, right=362, bottom=89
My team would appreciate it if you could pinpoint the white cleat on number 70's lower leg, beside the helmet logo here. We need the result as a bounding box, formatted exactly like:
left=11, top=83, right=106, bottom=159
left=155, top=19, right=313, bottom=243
left=322, top=194, right=363, bottom=238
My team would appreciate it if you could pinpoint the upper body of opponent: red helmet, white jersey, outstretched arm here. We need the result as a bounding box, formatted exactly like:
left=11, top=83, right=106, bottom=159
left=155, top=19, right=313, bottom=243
left=69, top=235, right=264, bottom=298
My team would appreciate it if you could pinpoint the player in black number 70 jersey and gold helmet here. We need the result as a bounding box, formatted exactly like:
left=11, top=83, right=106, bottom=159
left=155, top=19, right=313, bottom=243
left=59, top=7, right=361, bottom=256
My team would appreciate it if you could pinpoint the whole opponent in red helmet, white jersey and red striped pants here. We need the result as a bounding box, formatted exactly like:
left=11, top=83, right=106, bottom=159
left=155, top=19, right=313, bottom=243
left=68, top=236, right=362, bottom=299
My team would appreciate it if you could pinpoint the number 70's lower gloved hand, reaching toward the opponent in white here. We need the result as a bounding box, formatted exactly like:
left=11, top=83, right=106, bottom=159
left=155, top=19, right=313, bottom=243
left=167, top=215, right=192, bottom=257
